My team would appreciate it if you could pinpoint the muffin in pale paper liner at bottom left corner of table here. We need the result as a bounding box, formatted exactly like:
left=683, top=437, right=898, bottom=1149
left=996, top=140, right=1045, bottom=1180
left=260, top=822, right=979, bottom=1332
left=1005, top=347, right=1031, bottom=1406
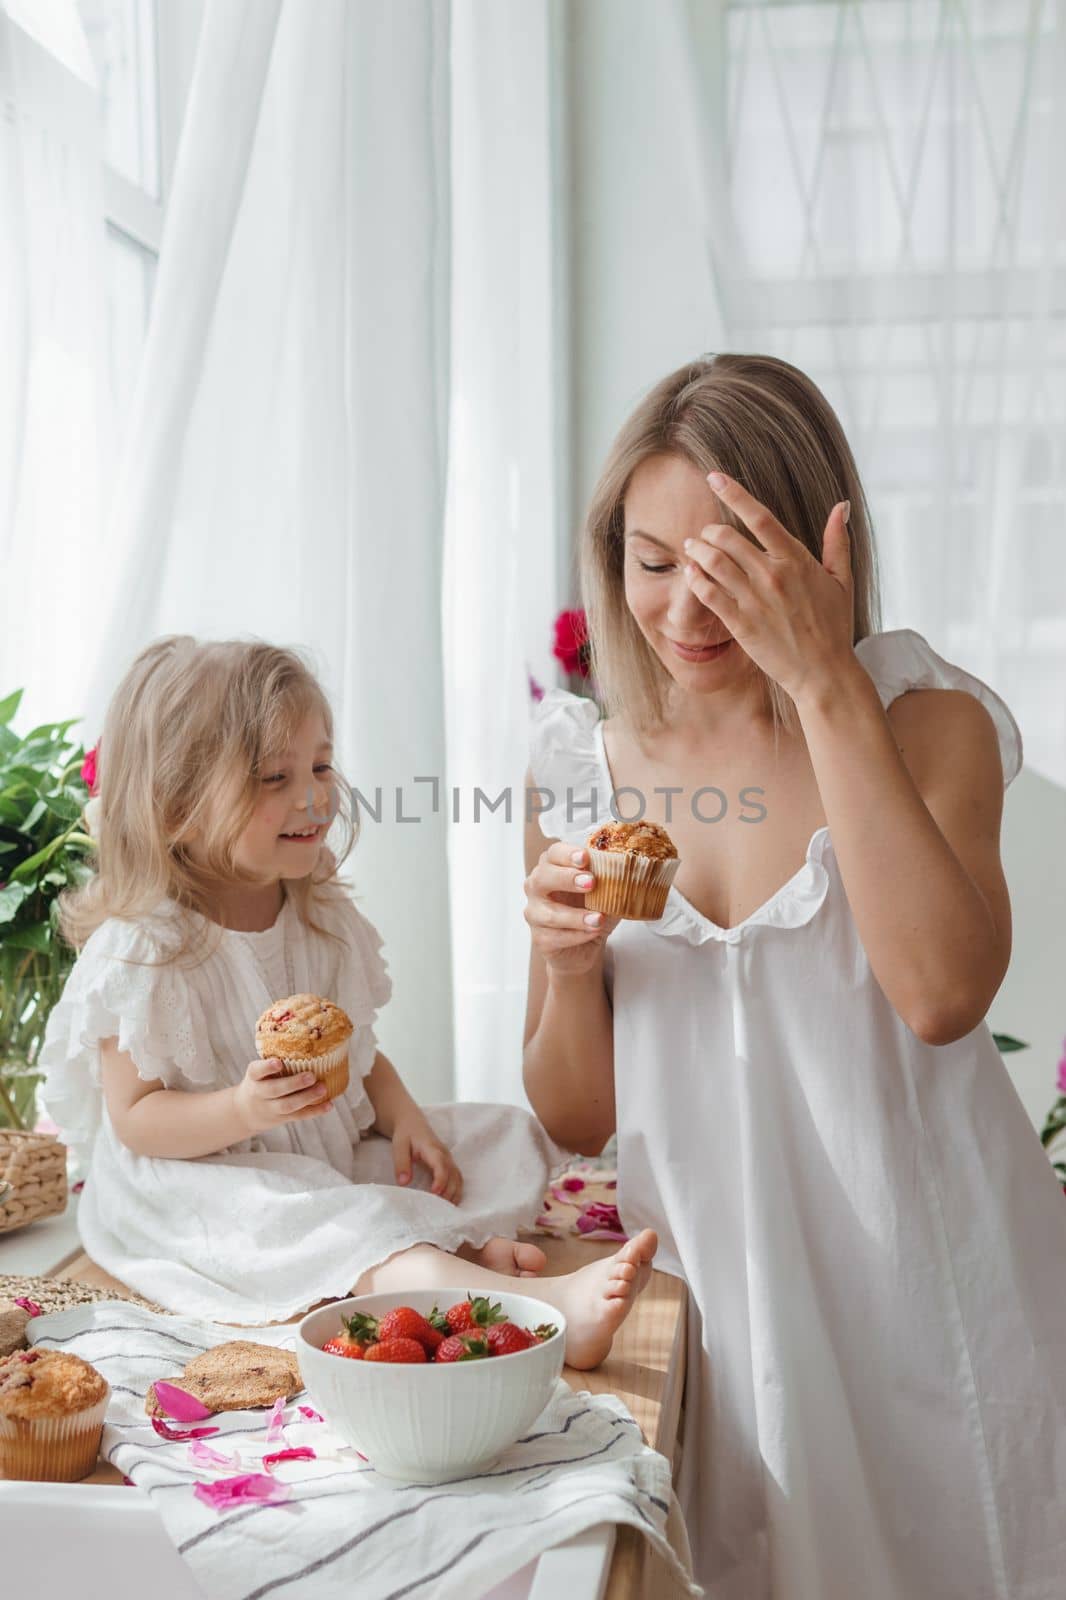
left=0, top=1350, right=110, bottom=1483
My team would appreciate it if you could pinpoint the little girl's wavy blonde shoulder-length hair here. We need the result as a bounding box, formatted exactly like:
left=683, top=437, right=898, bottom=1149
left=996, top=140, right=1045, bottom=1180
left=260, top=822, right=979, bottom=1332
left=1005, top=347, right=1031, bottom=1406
left=59, top=635, right=359, bottom=960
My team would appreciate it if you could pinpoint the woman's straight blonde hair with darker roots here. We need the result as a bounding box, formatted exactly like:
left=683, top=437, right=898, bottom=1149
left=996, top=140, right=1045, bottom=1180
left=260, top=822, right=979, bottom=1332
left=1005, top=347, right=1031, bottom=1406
left=579, top=355, right=880, bottom=734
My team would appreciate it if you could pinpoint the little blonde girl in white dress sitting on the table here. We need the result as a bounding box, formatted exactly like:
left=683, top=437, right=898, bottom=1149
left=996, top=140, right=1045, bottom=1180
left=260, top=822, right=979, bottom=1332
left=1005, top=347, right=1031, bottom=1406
left=42, top=637, right=655, bottom=1365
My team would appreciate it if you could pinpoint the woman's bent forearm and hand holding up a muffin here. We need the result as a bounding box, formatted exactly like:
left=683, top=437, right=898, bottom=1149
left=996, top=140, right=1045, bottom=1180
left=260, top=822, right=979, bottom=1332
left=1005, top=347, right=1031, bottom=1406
left=522, top=774, right=615, bottom=1155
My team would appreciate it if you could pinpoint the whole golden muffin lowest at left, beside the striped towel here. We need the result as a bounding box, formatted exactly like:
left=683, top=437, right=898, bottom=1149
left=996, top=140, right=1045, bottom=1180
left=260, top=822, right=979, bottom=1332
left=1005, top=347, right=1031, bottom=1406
left=0, top=1349, right=110, bottom=1483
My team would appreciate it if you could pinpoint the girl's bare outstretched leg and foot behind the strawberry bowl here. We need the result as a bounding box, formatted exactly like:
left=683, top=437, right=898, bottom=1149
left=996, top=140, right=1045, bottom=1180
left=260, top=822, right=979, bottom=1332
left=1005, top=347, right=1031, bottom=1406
left=352, top=1227, right=659, bottom=1368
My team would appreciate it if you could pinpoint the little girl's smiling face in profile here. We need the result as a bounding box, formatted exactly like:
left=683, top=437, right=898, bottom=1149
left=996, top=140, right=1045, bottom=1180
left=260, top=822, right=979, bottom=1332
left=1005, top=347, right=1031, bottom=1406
left=237, top=712, right=338, bottom=880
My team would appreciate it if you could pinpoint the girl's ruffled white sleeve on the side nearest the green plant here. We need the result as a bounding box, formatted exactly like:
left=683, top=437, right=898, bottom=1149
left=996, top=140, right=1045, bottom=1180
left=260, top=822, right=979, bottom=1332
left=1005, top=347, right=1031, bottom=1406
left=38, top=918, right=218, bottom=1170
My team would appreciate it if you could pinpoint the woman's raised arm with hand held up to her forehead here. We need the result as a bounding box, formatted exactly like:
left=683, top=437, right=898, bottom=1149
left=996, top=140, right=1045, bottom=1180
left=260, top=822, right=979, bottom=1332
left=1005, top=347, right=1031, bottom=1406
left=685, top=472, right=1010, bottom=1045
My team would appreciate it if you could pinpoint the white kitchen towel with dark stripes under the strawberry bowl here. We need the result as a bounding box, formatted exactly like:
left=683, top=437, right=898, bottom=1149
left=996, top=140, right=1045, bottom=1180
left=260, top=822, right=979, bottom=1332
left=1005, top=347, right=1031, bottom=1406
left=27, top=1301, right=699, bottom=1600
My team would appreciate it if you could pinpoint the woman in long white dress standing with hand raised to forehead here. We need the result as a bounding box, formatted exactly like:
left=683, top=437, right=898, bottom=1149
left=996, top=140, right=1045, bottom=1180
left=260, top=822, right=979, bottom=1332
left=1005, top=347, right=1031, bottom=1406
left=525, top=355, right=1066, bottom=1600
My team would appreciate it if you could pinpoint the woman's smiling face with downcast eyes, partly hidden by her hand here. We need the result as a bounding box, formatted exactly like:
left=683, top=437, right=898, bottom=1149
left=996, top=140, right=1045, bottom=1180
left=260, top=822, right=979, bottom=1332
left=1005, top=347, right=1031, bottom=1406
left=624, top=456, right=746, bottom=693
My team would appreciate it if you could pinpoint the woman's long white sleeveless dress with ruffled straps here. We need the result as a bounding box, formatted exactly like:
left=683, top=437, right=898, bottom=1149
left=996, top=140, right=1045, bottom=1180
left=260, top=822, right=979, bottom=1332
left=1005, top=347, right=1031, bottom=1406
left=531, top=629, right=1066, bottom=1600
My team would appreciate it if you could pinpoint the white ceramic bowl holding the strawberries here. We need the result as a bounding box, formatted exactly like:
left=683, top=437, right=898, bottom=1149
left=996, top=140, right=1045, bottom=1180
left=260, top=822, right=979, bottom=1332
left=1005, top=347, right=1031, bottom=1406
left=296, top=1290, right=567, bottom=1483
